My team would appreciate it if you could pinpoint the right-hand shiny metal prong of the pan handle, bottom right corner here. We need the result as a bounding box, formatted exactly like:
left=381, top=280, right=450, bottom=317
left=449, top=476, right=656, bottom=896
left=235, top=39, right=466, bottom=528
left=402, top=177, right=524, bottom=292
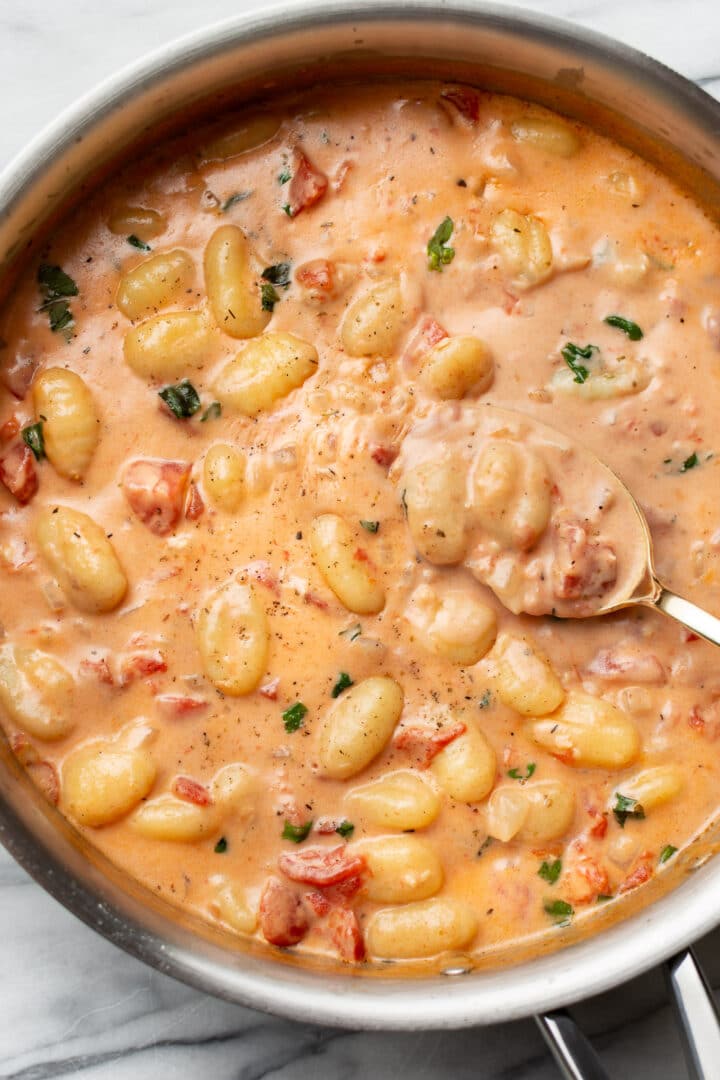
left=665, top=949, right=720, bottom=1080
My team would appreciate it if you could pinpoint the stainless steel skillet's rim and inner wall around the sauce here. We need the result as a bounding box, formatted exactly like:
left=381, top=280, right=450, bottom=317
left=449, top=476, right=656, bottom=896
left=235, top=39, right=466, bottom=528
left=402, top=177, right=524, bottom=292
left=0, top=0, right=720, bottom=1075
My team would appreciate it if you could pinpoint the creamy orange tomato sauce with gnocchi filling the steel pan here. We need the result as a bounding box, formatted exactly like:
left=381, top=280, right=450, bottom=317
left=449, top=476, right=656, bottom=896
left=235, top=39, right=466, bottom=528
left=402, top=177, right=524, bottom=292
left=0, top=82, right=720, bottom=964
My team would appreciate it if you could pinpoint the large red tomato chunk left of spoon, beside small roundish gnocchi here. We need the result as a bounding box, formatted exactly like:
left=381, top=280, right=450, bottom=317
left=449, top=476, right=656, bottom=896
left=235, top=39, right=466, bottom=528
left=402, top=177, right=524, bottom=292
left=122, top=458, right=191, bottom=537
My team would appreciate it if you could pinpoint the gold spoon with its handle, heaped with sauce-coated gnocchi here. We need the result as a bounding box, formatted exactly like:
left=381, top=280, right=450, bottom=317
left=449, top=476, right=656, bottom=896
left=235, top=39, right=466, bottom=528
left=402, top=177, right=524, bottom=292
left=393, top=404, right=720, bottom=645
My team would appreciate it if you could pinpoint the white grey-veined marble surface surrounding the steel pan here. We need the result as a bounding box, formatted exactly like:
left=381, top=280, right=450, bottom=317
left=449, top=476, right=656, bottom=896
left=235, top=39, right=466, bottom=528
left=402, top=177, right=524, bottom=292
left=0, top=0, right=720, bottom=1080
